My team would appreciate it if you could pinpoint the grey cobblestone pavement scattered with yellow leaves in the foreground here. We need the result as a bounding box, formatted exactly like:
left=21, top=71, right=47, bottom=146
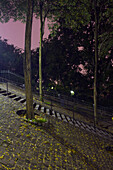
left=0, top=83, right=113, bottom=170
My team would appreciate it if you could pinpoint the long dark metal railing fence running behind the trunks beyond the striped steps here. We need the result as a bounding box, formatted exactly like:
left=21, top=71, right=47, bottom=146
left=0, top=72, right=113, bottom=128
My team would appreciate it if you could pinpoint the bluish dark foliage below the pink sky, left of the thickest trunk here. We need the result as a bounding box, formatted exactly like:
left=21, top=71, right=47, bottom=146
left=0, top=39, right=23, bottom=75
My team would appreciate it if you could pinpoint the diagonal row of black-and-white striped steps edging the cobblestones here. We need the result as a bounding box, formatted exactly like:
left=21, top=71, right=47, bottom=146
left=0, top=86, right=113, bottom=140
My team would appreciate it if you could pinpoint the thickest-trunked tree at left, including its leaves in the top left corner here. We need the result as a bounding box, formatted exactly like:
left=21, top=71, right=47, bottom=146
left=0, top=0, right=34, bottom=119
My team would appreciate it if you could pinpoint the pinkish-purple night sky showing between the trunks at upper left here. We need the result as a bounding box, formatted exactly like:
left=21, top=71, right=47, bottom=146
left=0, top=19, right=49, bottom=49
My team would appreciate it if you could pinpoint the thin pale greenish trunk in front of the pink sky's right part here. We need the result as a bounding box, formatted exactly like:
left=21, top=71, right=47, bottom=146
left=39, top=2, right=44, bottom=101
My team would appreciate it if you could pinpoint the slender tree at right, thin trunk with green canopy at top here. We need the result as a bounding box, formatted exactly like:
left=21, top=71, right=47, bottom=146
left=48, top=0, right=113, bottom=125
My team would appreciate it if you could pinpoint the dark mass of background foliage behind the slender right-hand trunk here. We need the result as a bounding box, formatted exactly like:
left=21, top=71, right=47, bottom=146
left=41, top=1, right=113, bottom=105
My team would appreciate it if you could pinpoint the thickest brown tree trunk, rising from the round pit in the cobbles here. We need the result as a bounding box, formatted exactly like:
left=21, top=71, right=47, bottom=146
left=24, top=0, right=34, bottom=119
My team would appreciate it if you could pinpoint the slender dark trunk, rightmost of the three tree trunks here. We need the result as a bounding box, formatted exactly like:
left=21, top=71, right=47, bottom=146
left=94, top=0, right=98, bottom=126
